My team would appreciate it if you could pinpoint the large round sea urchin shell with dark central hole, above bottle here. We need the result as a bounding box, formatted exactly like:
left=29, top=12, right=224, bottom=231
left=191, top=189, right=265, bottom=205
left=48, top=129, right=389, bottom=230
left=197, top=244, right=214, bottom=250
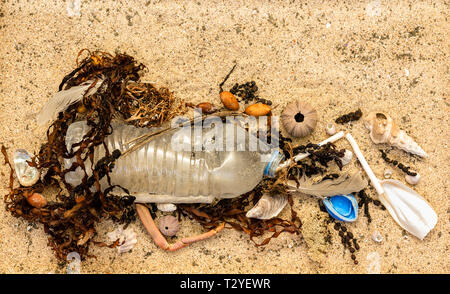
left=281, top=100, right=317, bottom=138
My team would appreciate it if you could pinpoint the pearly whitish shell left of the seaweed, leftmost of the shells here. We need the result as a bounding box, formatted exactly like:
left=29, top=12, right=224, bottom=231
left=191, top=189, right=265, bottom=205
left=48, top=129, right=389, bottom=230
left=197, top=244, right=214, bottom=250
left=14, top=149, right=40, bottom=187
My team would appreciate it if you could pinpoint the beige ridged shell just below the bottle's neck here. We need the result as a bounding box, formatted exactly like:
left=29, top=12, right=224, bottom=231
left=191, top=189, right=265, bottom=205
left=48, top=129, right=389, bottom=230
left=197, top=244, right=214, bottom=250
left=246, top=194, right=288, bottom=219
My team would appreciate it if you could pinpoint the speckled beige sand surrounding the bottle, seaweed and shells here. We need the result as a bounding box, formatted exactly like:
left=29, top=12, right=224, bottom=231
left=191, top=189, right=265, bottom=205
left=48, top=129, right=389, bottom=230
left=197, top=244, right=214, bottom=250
left=0, top=0, right=450, bottom=273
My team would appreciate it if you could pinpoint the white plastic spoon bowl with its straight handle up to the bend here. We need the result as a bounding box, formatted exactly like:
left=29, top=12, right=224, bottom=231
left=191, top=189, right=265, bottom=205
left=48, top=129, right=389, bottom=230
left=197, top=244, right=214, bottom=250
left=345, top=134, right=437, bottom=240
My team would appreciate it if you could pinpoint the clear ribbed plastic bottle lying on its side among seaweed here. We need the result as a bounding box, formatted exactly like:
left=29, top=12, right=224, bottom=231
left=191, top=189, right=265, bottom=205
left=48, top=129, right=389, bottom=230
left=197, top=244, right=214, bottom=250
left=65, top=121, right=283, bottom=203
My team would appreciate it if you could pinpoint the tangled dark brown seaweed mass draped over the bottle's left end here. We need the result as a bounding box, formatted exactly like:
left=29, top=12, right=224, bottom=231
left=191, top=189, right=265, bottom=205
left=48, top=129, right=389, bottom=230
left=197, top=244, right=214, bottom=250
left=2, top=50, right=185, bottom=259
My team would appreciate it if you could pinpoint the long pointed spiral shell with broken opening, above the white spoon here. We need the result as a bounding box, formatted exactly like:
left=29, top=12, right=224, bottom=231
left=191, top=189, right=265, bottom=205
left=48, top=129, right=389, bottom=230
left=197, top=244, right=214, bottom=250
left=364, top=112, right=428, bottom=157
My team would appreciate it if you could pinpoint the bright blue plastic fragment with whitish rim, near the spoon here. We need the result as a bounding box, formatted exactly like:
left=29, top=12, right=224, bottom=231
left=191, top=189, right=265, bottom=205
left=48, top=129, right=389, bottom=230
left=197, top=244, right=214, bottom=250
left=323, top=194, right=358, bottom=222
